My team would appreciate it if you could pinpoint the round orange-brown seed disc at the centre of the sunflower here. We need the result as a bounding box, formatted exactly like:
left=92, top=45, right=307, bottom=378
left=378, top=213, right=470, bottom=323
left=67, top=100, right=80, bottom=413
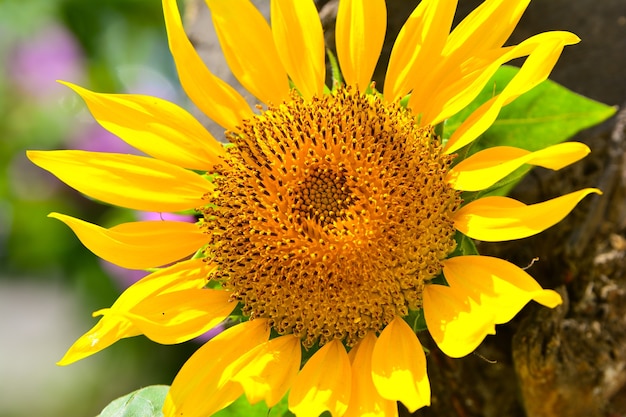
left=204, top=88, right=460, bottom=348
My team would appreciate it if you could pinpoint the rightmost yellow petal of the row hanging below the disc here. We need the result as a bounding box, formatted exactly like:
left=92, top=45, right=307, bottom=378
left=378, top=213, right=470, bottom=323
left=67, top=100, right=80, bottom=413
left=372, top=317, right=430, bottom=412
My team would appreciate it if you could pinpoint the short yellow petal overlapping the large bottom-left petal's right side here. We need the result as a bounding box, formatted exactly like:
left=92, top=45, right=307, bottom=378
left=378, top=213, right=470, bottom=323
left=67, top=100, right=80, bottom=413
left=230, top=334, right=301, bottom=407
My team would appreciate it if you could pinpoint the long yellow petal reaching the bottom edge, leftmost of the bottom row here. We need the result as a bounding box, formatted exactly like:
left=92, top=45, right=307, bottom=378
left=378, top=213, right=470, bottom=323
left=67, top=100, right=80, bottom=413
left=163, top=319, right=270, bottom=417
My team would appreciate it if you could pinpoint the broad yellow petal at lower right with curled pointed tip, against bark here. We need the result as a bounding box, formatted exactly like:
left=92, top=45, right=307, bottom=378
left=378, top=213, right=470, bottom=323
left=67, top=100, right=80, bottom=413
left=424, top=256, right=562, bottom=357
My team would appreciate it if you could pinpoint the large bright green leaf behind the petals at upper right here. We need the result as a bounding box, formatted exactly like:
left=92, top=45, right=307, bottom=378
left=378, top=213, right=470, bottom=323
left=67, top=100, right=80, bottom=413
left=444, top=65, right=616, bottom=157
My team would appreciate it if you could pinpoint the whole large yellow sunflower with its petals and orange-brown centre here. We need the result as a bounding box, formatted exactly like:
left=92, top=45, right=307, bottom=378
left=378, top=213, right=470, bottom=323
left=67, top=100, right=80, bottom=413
left=28, top=0, right=599, bottom=416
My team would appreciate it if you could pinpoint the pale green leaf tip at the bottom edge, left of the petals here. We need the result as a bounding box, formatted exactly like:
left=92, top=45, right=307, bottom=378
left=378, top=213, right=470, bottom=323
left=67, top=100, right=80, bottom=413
left=98, top=385, right=170, bottom=417
